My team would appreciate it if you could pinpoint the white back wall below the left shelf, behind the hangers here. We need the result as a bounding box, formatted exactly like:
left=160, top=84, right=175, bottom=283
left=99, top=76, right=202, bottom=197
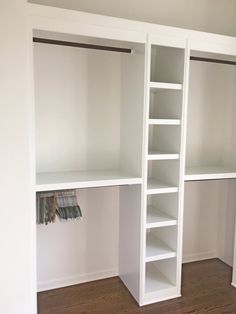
left=37, top=187, right=119, bottom=290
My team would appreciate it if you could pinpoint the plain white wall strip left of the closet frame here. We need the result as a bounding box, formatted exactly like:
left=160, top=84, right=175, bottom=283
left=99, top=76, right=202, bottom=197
left=0, top=0, right=35, bottom=314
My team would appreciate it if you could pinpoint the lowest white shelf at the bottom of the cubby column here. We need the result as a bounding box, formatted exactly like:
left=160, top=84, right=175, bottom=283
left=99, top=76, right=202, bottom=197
left=145, top=263, right=174, bottom=293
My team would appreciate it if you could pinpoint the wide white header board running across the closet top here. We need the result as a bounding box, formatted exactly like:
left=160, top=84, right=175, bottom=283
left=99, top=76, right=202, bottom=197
left=27, top=3, right=236, bottom=54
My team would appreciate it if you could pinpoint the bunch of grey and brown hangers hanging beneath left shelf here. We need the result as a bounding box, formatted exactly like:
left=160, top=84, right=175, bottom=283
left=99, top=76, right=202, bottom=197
left=37, top=190, right=82, bottom=225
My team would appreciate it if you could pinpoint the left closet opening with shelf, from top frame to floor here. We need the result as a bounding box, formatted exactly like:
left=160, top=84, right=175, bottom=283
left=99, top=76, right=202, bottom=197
left=33, top=30, right=145, bottom=301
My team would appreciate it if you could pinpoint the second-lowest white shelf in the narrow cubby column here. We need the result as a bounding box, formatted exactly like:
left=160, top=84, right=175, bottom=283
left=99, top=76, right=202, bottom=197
left=146, top=232, right=176, bottom=262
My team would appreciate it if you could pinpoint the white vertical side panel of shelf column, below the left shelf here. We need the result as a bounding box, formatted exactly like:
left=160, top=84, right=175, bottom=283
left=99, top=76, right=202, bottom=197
left=119, top=185, right=142, bottom=303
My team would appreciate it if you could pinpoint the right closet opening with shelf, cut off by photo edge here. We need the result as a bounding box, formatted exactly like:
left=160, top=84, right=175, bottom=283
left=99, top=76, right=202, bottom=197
left=183, top=51, right=236, bottom=292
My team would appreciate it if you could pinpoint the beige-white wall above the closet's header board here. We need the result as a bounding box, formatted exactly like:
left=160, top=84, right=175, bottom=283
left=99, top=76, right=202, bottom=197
left=29, top=0, right=236, bottom=36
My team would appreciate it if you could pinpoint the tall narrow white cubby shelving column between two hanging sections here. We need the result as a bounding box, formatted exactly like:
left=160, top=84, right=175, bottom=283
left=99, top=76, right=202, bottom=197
left=141, top=37, right=189, bottom=304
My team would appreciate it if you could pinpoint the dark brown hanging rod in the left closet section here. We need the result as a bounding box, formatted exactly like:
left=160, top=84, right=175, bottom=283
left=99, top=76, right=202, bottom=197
left=33, top=37, right=132, bottom=53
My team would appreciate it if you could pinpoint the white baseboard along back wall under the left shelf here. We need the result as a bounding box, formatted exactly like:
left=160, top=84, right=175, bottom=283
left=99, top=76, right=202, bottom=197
left=37, top=269, right=118, bottom=292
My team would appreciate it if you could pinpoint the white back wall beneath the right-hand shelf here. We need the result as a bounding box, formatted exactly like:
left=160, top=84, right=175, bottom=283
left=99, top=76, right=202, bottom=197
left=183, top=181, right=220, bottom=262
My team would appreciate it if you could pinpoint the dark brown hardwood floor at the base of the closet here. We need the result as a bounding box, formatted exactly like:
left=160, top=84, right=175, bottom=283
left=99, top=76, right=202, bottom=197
left=38, top=259, right=236, bottom=314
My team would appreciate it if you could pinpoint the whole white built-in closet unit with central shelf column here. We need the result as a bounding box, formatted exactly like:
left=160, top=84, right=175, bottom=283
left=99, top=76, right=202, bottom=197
left=28, top=4, right=236, bottom=305
